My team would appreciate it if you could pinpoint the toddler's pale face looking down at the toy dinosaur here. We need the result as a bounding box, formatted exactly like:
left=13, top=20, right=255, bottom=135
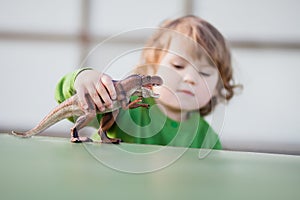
left=155, top=38, right=219, bottom=118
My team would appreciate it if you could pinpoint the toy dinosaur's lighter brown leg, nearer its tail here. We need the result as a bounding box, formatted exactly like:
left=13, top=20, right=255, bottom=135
left=71, top=112, right=96, bottom=143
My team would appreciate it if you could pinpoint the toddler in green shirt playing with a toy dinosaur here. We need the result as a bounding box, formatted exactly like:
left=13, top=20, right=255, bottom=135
left=56, top=15, right=236, bottom=149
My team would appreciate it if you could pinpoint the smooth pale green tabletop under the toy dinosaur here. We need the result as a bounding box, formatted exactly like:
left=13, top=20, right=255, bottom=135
left=0, top=134, right=300, bottom=200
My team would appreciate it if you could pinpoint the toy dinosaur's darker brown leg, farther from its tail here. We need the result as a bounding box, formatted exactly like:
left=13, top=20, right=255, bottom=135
left=98, top=110, right=121, bottom=144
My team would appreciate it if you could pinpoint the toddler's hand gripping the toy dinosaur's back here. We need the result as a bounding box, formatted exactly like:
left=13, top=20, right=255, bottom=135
left=74, top=70, right=117, bottom=111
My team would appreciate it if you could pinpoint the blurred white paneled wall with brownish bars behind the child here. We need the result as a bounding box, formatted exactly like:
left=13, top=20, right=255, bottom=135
left=0, top=0, right=300, bottom=155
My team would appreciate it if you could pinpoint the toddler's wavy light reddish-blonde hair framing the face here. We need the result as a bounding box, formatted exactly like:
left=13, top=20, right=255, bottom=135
left=135, top=15, right=237, bottom=116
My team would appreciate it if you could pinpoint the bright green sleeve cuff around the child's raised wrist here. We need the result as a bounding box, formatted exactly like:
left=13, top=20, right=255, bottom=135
left=55, top=68, right=90, bottom=103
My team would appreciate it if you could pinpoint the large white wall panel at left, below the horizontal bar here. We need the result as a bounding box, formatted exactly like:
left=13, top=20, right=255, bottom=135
left=0, top=40, right=78, bottom=135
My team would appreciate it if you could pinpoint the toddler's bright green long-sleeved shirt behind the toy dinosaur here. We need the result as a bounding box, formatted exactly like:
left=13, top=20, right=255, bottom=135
left=55, top=69, right=222, bottom=149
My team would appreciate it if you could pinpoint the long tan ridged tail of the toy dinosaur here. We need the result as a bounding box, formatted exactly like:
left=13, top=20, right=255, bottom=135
left=11, top=97, right=82, bottom=138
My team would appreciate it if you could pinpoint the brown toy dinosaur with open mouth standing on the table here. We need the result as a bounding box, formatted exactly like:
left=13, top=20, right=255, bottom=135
left=12, top=74, right=163, bottom=144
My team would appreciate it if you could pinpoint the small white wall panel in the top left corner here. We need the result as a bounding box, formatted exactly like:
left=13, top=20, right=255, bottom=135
left=0, top=0, right=81, bottom=34
